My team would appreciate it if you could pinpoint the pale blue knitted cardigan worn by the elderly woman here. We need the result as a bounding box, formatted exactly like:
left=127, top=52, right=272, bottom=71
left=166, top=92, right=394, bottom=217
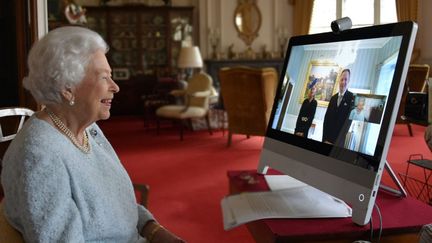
left=1, top=115, right=154, bottom=243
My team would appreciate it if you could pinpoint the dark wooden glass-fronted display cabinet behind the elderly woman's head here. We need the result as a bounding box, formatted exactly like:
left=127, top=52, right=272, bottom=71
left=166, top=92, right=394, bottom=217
left=86, top=5, right=197, bottom=77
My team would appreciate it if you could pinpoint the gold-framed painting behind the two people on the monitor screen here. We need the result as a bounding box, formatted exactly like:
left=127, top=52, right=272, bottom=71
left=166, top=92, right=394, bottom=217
left=299, top=60, right=341, bottom=107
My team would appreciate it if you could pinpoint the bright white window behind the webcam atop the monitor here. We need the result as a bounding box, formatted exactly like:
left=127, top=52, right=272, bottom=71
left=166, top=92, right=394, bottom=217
left=309, top=0, right=397, bottom=34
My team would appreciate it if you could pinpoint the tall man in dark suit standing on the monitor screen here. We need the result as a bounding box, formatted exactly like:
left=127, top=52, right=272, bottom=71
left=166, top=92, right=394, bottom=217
left=322, top=69, right=354, bottom=147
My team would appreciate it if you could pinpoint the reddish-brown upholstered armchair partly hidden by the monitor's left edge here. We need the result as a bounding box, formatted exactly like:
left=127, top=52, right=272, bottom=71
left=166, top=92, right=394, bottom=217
left=219, top=67, right=278, bottom=146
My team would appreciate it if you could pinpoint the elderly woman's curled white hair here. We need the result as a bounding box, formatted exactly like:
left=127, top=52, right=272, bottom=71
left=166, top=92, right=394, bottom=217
left=23, top=26, right=108, bottom=104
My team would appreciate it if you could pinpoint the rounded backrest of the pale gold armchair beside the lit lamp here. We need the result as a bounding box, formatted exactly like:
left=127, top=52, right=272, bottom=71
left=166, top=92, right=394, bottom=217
left=186, top=72, right=213, bottom=109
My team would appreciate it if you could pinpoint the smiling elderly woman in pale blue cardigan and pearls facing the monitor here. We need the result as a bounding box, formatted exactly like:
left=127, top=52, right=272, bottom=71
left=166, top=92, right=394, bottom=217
left=2, top=27, right=183, bottom=242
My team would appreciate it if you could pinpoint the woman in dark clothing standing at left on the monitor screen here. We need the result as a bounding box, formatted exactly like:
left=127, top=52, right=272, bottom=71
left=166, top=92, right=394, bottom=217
left=294, top=79, right=318, bottom=138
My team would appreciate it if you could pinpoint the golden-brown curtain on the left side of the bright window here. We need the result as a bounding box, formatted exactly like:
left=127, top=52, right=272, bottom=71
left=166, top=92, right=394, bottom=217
left=289, top=0, right=314, bottom=35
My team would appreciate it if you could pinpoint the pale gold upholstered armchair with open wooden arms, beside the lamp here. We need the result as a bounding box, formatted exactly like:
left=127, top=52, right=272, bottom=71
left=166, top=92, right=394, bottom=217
left=156, top=72, right=213, bottom=140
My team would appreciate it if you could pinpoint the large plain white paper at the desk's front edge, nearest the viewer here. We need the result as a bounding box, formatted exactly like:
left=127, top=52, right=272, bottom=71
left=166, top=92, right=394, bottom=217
left=221, top=185, right=352, bottom=230
